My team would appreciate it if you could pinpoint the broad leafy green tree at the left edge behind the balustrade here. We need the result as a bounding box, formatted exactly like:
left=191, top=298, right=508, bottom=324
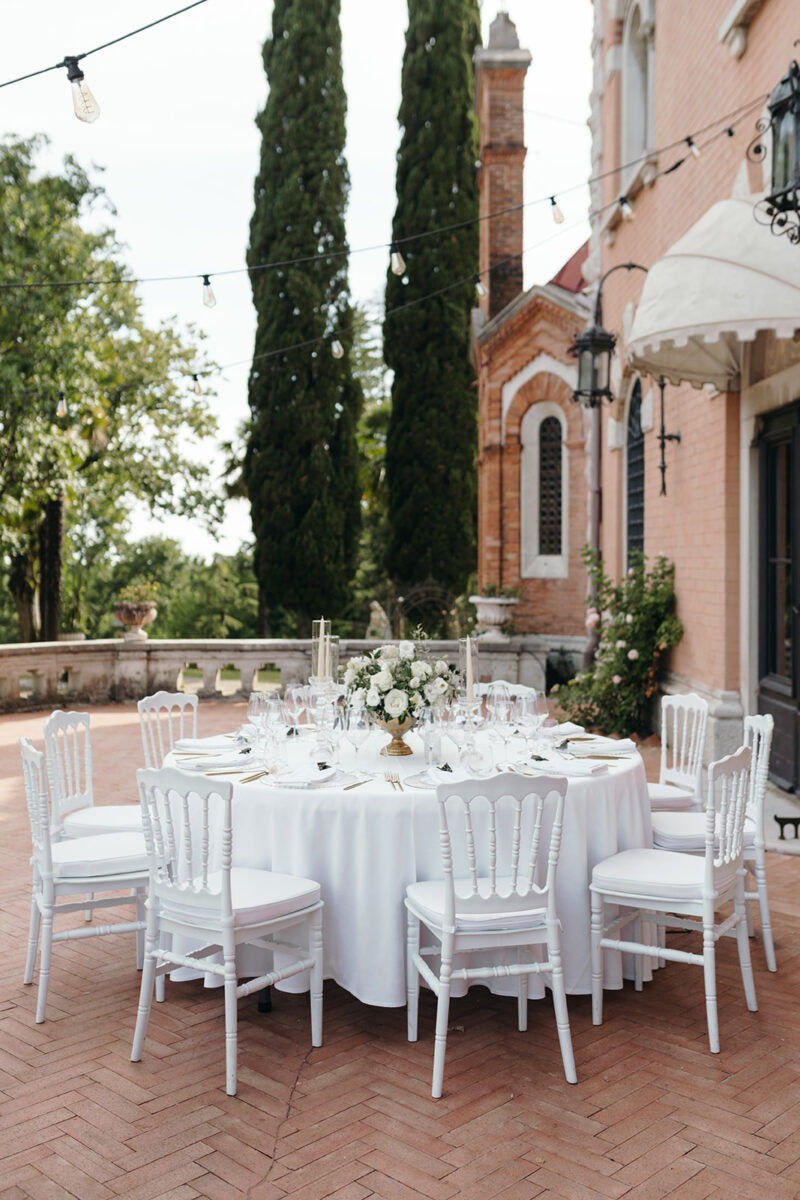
left=0, top=138, right=219, bottom=641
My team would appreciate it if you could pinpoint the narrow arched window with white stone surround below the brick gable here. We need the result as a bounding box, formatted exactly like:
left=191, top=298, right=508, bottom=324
left=519, top=401, right=570, bottom=578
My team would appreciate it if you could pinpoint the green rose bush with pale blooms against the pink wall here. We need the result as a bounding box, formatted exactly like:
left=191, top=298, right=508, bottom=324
left=551, top=548, right=684, bottom=734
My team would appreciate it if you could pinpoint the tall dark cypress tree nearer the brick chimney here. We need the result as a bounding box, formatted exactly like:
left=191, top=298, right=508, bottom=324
left=384, top=0, right=480, bottom=619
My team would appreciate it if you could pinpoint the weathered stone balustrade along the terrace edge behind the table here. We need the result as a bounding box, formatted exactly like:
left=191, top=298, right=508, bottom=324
left=0, top=635, right=583, bottom=712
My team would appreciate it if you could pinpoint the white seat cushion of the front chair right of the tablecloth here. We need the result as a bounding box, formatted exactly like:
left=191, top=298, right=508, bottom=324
left=591, top=848, right=736, bottom=900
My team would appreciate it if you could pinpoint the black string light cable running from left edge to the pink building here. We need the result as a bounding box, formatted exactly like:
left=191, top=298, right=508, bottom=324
left=0, top=88, right=766, bottom=297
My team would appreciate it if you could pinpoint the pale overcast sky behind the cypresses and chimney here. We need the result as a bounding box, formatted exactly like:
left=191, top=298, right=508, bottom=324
left=0, top=0, right=591, bottom=557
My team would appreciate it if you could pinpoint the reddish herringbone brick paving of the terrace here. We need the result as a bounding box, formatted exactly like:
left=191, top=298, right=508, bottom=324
left=0, top=701, right=800, bottom=1200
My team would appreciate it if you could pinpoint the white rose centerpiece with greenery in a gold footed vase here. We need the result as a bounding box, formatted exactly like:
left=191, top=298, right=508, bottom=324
left=344, top=642, right=458, bottom=755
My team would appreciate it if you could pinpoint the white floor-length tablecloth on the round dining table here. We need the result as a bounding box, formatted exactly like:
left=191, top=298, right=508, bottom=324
left=168, top=732, right=652, bottom=1007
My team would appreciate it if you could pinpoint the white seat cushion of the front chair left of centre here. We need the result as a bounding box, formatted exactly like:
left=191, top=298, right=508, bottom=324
left=163, top=866, right=319, bottom=925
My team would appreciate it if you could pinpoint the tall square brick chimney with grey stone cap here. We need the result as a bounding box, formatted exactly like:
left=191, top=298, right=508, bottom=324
left=475, top=12, right=530, bottom=318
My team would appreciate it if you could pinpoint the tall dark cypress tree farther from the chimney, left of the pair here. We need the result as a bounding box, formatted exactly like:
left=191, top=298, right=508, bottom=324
left=245, top=0, right=361, bottom=632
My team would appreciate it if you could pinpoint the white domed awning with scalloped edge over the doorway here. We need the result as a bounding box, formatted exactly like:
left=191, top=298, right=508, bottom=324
left=626, top=197, right=800, bottom=391
